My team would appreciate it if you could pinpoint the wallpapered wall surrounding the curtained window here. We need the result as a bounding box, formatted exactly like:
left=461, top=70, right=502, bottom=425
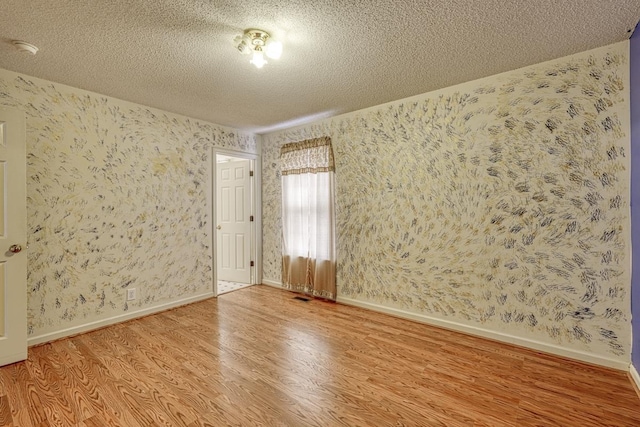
left=263, top=42, right=630, bottom=361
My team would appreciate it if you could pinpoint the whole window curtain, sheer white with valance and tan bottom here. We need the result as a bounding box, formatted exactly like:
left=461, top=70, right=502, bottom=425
left=280, top=137, right=336, bottom=300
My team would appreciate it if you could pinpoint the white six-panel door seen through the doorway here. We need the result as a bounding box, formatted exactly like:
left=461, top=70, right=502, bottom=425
left=216, top=159, right=251, bottom=283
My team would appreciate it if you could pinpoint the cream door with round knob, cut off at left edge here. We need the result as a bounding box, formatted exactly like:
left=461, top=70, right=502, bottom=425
left=0, top=108, right=27, bottom=366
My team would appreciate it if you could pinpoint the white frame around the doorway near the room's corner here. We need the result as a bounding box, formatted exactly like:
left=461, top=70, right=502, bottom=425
left=208, top=147, right=262, bottom=296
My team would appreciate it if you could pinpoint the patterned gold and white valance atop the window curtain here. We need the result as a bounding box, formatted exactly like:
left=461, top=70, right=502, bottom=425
left=280, top=136, right=335, bottom=175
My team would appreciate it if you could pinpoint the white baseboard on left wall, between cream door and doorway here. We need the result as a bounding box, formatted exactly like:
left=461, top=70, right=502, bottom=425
left=27, top=292, right=215, bottom=347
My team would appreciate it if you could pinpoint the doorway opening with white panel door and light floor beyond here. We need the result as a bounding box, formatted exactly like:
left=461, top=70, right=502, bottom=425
left=212, top=150, right=260, bottom=295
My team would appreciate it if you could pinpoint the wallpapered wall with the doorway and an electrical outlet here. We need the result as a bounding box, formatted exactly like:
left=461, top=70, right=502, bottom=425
left=0, top=70, right=257, bottom=336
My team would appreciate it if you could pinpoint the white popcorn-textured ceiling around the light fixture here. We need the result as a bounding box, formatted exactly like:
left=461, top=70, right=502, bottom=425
left=0, top=0, right=640, bottom=133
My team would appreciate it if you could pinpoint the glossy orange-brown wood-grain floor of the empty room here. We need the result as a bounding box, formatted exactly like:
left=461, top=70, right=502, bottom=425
left=0, top=286, right=640, bottom=427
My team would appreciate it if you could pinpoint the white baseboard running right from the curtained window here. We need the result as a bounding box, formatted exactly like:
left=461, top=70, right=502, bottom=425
left=336, top=296, right=628, bottom=372
